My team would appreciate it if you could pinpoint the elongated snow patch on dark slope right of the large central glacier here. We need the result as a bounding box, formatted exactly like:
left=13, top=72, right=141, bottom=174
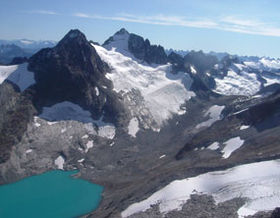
left=195, top=105, right=225, bottom=129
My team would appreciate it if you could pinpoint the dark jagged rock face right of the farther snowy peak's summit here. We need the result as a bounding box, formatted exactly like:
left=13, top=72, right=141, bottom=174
left=128, top=33, right=167, bottom=64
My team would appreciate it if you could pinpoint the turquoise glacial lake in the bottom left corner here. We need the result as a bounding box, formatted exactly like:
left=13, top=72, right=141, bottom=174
left=0, top=170, right=103, bottom=218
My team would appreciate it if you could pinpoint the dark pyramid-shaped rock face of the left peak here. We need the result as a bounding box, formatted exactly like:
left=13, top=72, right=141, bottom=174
left=29, top=30, right=127, bottom=123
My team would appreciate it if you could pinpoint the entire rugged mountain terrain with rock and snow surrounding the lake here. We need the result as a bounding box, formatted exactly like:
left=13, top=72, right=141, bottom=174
left=0, top=29, right=280, bottom=218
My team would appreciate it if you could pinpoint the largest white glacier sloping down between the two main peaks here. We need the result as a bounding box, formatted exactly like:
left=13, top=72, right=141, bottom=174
left=93, top=45, right=195, bottom=129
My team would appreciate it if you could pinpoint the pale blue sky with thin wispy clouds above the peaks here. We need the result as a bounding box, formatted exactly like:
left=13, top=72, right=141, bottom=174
left=0, top=0, right=280, bottom=57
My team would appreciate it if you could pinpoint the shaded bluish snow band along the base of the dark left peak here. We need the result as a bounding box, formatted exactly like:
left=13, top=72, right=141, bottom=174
left=39, top=101, right=115, bottom=139
